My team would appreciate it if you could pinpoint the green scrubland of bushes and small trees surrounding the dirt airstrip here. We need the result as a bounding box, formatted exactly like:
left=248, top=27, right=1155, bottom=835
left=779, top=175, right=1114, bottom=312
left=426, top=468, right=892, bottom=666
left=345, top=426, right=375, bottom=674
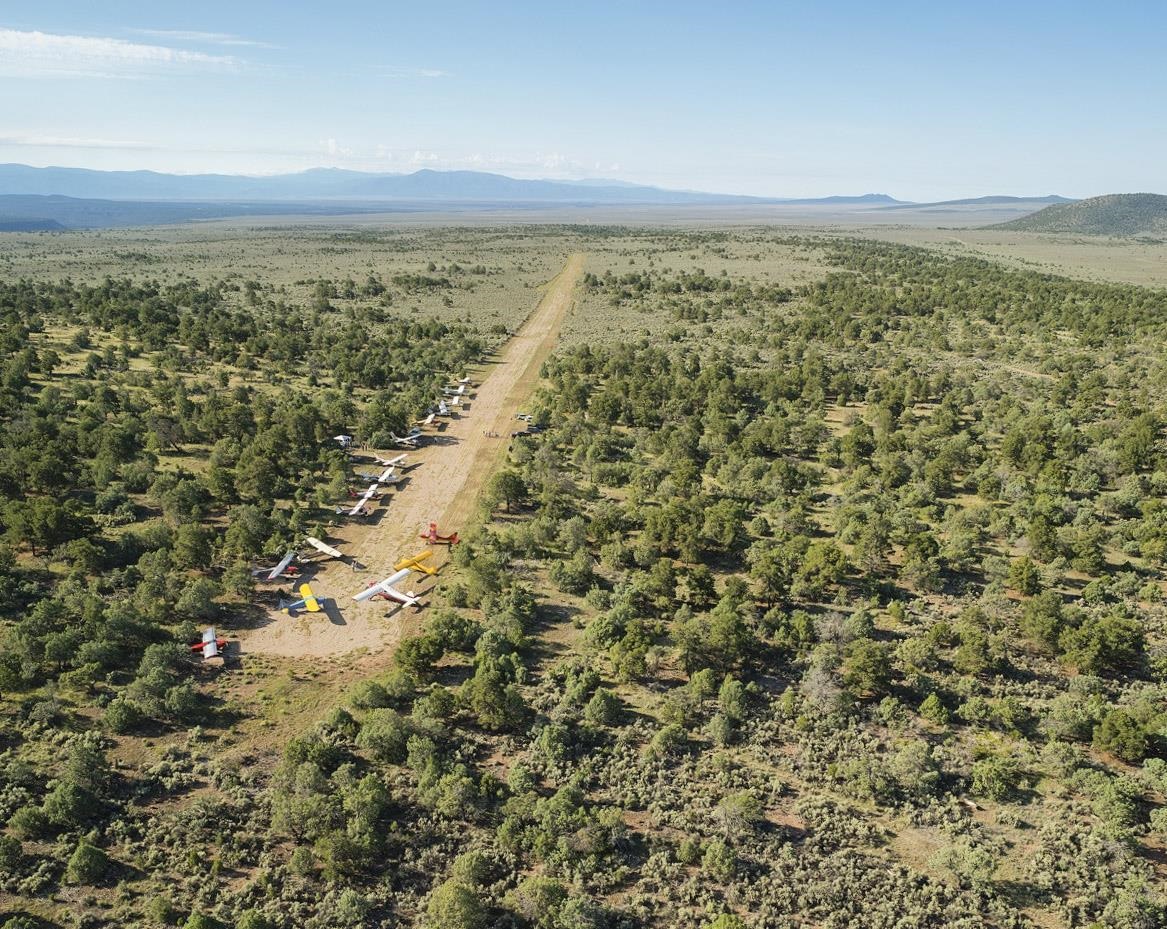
left=0, top=229, right=1167, bottom=929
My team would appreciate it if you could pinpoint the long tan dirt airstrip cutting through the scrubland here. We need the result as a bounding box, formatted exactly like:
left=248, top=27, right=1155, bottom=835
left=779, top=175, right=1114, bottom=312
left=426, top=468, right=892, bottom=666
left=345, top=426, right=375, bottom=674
left=240, top=254, right=584, bottom=661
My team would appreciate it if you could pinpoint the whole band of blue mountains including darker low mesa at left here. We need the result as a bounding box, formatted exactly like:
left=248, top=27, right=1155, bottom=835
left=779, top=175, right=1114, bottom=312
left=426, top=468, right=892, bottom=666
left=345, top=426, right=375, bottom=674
left=0, top=165, right=1092, bottom=231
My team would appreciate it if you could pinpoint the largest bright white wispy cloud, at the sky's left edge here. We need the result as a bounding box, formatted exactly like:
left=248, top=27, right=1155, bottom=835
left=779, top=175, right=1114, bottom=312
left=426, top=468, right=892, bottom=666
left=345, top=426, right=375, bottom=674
left=0, top=29, right=243, bottom=77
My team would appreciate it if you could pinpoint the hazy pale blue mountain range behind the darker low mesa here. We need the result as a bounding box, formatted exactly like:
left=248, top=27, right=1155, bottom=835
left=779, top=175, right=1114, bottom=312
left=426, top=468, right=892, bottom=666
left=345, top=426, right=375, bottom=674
left=0, top=165, right=899, bottom=205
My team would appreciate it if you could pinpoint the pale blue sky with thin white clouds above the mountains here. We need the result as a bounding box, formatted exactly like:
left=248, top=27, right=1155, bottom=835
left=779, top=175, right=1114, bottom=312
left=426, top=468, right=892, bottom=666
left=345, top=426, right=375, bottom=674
left=0, top=0, right=1167, bottom=200
